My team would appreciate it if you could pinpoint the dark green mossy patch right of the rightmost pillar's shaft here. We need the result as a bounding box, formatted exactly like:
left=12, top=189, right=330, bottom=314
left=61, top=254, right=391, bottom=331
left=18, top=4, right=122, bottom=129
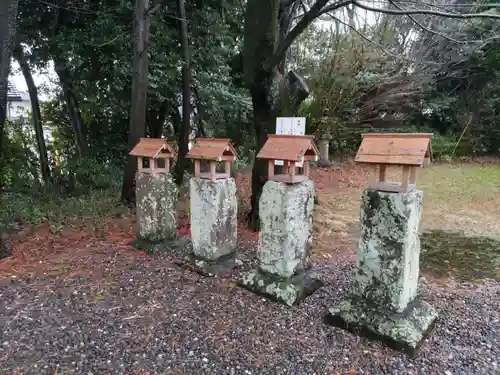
left=420, top=230, right=500, bottom=281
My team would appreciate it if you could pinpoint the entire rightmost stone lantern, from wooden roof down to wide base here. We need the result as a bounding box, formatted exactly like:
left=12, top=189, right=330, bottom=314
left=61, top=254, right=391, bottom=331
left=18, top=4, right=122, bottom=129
left=329, top=133, right=437, bottom=355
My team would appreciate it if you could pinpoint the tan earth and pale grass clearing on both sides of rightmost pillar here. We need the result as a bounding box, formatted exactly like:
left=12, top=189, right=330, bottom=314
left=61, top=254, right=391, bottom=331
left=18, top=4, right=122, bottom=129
left=313, top=163, right=500, bottom=253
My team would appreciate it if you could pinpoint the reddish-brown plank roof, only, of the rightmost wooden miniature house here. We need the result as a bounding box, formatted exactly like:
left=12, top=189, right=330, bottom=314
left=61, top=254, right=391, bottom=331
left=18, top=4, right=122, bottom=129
left=354, top=133, right=433, bottom=167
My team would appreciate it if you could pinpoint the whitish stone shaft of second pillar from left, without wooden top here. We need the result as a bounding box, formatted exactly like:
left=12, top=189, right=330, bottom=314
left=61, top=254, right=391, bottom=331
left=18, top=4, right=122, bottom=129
left=190, top=177, right=238, bottom=273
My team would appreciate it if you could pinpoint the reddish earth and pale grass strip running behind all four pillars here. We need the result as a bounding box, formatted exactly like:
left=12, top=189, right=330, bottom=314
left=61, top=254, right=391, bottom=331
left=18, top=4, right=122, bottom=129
left=0, top=162, right=500, bottom=277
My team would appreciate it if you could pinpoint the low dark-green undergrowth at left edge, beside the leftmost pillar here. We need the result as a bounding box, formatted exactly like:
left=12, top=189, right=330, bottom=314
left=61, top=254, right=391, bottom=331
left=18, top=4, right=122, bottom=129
left=0, top=158, right=127, bottom=231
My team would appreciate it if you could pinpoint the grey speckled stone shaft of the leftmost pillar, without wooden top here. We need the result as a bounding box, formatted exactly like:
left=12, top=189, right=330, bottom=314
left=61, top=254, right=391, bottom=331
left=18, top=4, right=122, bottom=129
left=136, top=172, right=177, bottom=242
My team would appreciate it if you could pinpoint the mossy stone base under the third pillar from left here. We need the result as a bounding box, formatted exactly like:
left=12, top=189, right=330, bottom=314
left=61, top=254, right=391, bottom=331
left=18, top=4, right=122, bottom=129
left=240, top=270, right=323, bottom=306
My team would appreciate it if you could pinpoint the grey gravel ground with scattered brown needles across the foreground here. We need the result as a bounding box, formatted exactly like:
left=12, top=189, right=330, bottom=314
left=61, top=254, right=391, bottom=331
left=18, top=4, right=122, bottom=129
left=0, top=247, right=500, bottom=375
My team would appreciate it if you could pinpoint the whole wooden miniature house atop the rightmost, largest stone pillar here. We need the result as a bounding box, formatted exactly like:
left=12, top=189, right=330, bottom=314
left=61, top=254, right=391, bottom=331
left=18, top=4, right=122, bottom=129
left=354, top=133, right=433, bottom=193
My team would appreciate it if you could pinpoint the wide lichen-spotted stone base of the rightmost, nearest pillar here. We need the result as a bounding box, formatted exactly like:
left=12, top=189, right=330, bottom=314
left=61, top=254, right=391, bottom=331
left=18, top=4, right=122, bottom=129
left=326, top=297, right=438, bottom=356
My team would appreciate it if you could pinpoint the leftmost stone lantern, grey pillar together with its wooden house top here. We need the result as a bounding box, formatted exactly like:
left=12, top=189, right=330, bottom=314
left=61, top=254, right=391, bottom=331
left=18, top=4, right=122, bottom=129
left=130, top=138, right=177, bottom=243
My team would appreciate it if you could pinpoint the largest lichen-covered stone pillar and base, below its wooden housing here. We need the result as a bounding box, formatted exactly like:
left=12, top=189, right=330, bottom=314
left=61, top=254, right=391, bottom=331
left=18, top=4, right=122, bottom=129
left=329, top=189, right=437, bottom=354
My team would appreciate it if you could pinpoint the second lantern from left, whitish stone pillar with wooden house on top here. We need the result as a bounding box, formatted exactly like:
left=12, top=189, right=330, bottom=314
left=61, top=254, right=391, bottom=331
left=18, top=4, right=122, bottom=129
left=187, top=138, right=238, bottom=274
